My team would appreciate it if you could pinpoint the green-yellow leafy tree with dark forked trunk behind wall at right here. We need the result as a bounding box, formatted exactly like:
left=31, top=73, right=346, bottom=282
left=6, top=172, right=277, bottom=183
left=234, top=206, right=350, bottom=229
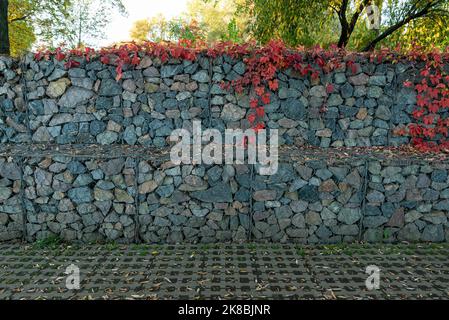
left=246, top=0, right=449, bottom=51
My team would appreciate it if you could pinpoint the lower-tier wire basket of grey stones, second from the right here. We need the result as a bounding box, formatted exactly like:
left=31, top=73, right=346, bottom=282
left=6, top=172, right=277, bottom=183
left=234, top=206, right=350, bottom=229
left=252, top=156, right=365, bottom=243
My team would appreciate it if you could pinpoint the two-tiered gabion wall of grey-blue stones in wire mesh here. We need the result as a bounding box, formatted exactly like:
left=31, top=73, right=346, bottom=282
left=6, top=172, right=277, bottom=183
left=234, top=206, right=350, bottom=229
left=0, top=57, right=449, bottom=244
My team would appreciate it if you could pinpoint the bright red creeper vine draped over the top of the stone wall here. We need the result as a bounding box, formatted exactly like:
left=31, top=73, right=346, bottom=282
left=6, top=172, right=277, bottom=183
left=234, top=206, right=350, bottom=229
left=35, top=40, right=449, bottom=152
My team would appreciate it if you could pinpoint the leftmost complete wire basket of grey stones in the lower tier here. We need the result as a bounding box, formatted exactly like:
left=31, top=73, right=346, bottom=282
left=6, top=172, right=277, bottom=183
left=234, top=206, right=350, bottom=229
left=23, top=155, right=137, bottom=243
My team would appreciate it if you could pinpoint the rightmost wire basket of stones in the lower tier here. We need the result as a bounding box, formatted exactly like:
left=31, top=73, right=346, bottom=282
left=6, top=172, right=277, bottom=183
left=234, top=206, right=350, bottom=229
left=363, top=160, right=449, bottom=242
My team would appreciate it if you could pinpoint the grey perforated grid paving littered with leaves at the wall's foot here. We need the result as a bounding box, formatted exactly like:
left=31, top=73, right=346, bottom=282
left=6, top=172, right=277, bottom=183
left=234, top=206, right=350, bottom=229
left=0, top=244, right=449, bottom=299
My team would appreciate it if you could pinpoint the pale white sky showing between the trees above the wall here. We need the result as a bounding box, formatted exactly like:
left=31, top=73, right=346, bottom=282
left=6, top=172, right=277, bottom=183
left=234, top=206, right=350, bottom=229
left=100, top=0, right=188, bottom=46
